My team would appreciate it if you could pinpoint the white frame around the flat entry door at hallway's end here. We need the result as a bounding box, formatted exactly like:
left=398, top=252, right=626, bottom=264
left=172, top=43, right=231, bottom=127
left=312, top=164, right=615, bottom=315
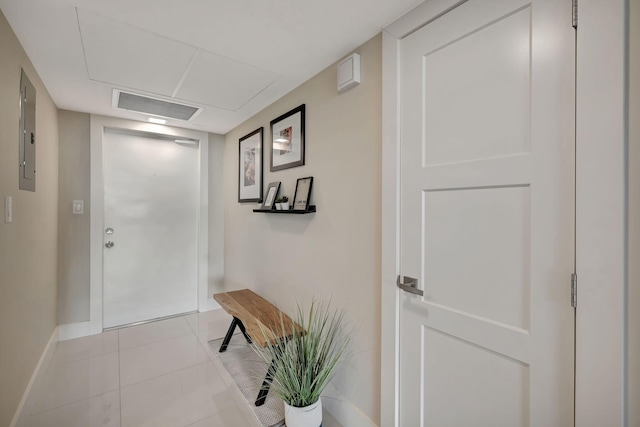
left=89, top=115, right=212, bottom=334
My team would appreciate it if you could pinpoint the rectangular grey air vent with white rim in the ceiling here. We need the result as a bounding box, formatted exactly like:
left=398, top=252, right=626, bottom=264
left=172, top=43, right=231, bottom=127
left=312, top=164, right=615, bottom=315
left=113, top=89, right=202, bottom=120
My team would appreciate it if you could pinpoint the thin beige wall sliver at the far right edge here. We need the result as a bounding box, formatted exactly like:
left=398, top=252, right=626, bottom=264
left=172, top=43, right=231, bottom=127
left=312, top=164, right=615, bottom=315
left=627, top=0, right=640, bottom=427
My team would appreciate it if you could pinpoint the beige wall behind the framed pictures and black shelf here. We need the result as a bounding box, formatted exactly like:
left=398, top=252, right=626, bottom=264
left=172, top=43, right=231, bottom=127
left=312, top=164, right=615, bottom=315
left=224, top=35, right=382, bottom=424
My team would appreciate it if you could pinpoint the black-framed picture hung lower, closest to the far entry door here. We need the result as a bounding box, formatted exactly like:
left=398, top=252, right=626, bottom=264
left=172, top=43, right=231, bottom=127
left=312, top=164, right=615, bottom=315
left=238, top=128, right=264, bottom=203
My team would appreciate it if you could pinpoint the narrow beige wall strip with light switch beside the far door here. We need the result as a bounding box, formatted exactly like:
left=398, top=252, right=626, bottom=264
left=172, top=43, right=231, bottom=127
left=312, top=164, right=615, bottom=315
left=58, top=110, right=90, bottom=325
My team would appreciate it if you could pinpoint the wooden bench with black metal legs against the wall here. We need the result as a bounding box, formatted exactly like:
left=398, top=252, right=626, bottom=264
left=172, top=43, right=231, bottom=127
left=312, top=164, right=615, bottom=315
left=213, top=289, right=301, bottom=406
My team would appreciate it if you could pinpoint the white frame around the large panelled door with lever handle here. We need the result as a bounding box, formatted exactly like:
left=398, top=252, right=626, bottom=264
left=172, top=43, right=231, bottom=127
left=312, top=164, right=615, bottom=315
left=380, top=0, right=628, bottom=426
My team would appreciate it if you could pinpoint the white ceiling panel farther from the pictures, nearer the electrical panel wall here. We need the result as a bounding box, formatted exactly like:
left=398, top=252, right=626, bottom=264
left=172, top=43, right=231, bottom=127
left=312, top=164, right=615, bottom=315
left=78, top=9, right=197, bottom=96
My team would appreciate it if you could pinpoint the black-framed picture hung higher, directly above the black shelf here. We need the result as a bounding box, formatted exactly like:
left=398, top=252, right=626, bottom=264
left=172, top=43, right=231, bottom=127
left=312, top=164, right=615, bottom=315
left=271, top=104, right=304, bottom=172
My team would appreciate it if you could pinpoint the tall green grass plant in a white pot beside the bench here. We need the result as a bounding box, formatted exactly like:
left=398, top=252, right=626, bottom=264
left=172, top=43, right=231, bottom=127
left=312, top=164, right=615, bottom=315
left=253, top=301, right=350, bottom=427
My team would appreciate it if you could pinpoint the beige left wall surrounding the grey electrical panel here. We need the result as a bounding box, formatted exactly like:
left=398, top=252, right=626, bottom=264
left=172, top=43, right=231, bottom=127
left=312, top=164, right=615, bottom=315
left=0, top=8, right=58, bottom=426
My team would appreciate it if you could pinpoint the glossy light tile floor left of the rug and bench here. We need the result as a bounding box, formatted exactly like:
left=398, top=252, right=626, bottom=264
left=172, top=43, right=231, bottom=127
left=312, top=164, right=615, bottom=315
left=18, top=310, right=259, bottom=427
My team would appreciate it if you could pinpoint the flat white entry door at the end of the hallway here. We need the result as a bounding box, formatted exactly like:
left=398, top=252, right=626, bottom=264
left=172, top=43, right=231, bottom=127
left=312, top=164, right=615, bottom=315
left=103, top=129, right=200, bottom=328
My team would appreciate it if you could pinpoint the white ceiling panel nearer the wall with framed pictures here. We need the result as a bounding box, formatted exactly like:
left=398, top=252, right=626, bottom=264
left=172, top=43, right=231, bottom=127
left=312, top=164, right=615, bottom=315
left=176, top=50, right=280, bottom=111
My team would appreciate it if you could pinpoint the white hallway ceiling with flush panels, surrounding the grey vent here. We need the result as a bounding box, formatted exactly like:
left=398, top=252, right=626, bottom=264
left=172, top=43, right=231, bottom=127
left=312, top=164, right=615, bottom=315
left=0, top=0, right=421, bottom=134
